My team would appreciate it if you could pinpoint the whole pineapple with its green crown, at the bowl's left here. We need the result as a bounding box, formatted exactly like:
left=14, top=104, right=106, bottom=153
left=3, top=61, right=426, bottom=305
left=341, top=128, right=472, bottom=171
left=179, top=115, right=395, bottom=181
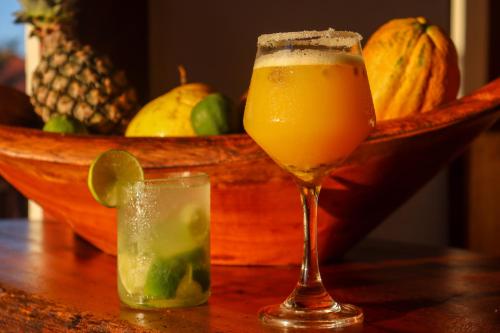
left=16, top=0, right=138, bottom=134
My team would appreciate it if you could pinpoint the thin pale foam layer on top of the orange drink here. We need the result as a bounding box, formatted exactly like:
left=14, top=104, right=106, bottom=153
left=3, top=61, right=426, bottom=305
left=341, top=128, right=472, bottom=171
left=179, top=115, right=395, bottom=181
left=254, top=50, right=363, bottom=68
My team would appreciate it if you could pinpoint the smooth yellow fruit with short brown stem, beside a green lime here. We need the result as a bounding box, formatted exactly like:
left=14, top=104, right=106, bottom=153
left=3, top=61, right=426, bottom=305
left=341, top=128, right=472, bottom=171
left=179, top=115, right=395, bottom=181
left=125, top=65, right=212, bottom=137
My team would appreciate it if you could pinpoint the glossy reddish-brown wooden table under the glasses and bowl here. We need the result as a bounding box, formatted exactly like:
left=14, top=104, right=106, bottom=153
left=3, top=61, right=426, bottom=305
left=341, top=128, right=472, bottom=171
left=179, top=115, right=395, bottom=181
left=0, top=220, right=500, bottom=333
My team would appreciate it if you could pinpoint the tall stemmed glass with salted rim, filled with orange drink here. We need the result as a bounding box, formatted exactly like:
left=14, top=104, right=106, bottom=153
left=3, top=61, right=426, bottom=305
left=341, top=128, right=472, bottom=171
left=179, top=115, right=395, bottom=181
left=244, top=29, right=375, bottom=328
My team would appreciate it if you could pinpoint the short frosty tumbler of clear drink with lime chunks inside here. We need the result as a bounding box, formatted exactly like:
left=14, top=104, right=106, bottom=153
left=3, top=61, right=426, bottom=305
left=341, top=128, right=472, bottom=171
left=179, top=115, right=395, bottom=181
left=117, top=172, right=210, bottom=309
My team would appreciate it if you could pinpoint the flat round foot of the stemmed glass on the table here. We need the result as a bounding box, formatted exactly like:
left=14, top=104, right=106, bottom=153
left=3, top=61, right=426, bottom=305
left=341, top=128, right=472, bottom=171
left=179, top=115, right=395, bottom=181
left=259, top=303, right=363, bottom=329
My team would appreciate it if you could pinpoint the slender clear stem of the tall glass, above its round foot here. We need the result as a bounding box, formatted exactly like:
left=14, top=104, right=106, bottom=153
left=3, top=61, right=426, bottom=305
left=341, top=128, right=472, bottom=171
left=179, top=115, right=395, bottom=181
left=283, top=184, right=336, bottom=310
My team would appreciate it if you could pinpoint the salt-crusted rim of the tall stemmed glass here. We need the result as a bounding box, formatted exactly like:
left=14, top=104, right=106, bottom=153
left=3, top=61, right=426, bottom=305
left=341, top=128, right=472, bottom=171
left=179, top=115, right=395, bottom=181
left=257, top=28, right=363, bottom=47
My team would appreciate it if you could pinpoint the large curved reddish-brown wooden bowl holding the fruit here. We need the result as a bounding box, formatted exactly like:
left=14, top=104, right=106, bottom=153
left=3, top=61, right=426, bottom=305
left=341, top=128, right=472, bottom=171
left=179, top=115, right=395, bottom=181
left=0, top=79, right=500, bottom=265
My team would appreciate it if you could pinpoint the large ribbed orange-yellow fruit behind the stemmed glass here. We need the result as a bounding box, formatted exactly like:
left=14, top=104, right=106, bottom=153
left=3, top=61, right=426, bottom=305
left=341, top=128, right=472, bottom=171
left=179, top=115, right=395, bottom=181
left=363, top=17, right=460, bottom=121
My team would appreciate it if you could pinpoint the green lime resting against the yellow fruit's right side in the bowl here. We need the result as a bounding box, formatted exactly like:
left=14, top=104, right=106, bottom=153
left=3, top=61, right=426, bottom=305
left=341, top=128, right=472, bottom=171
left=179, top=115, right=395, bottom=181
left=191, top=94, right=231, bottom=135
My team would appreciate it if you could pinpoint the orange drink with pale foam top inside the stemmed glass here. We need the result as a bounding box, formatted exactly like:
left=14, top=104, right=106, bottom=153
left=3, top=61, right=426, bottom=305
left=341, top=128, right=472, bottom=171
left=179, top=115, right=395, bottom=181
left=244, top=44, right=375, bottom=183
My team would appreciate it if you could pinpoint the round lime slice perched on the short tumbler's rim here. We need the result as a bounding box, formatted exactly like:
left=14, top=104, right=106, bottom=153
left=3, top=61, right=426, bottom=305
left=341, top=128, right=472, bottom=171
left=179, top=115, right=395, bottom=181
left=87, top=149, right=144, bottom=208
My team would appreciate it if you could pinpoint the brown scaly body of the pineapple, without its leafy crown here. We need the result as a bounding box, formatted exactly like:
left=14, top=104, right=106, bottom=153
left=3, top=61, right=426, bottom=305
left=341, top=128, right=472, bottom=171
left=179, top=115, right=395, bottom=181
left=31, top=40, right=138, bottom=134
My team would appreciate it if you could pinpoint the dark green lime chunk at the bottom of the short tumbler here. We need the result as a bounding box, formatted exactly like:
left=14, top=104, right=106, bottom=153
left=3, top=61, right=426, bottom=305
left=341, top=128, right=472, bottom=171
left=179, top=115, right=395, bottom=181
left=144, top=257, right=187, bottom=298
